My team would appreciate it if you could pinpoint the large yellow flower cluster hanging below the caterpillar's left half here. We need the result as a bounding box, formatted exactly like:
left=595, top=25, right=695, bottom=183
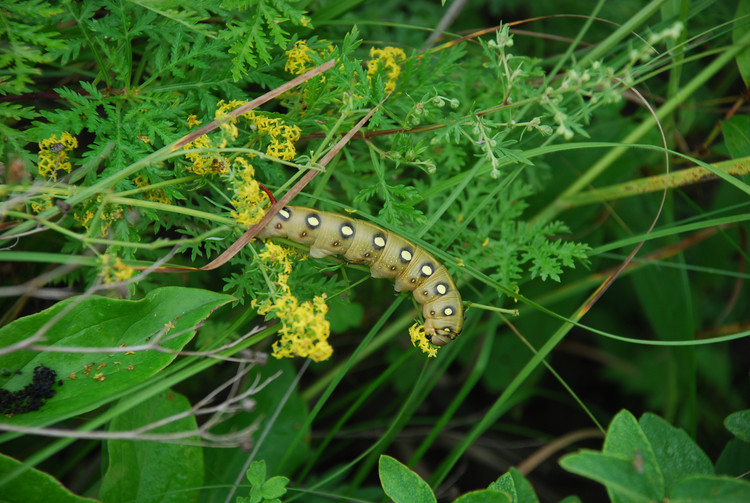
left=251, top=243, right=333, bottom=362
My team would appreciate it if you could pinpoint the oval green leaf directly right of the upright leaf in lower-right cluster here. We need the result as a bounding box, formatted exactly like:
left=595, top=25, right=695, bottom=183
left=640, top=413, right=714, bottom=493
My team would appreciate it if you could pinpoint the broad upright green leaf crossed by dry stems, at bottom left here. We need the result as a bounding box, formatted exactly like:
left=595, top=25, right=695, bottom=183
left=99, top=391, right=203, bottom=503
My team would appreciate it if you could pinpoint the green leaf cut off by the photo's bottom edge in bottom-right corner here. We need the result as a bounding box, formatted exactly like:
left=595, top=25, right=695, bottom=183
left=669, top=475, right=750, bottom=503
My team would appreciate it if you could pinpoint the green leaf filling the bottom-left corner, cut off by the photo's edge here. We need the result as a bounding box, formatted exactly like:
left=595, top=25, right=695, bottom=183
left=0, top=454, right=96, bottom=503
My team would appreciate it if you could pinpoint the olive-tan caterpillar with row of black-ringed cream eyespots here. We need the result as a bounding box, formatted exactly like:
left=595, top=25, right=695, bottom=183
left=258, top=206, right=464, bottom=346
